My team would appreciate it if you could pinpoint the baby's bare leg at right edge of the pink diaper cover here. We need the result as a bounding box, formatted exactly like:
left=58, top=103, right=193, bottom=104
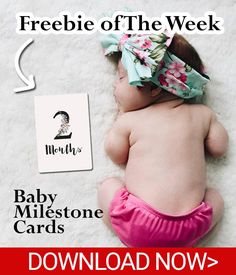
left=204, top=188, right=224, bottom=231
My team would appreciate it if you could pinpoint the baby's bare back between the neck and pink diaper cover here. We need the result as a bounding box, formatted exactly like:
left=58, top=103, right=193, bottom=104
left=125, top=101, right=210, bottom=215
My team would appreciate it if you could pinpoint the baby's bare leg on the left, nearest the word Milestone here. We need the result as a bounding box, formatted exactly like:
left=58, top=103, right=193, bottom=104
left=98, top=178, right=124, bottom=229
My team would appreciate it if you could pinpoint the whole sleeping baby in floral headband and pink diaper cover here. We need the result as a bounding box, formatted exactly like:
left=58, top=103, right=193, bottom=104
left=98, top=33, right=228, bottom=247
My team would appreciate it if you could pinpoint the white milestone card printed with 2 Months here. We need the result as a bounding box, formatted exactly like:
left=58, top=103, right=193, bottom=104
left=35, top=93, right=92, bottom=173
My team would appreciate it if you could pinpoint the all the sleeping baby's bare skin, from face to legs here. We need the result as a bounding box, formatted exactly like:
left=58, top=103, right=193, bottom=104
left=98, top=60, right=228, bottom=237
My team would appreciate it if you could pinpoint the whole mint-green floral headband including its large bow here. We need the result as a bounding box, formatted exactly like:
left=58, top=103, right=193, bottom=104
left=101, top=32, right=209, bottom=99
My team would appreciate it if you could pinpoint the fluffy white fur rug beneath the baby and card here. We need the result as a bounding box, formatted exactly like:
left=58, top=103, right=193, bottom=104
left=0, top=0, right=236, bottom=247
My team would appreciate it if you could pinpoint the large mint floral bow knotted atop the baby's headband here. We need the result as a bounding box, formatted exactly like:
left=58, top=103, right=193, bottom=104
left=101, top=33, right=172, bottom=86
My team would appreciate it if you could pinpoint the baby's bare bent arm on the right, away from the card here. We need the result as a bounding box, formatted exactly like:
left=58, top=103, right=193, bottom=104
left=205, top=112, right=228, bottom=157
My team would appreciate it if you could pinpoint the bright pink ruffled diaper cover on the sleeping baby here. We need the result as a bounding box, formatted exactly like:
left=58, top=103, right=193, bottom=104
left=110, top=188, right=212, bottom=247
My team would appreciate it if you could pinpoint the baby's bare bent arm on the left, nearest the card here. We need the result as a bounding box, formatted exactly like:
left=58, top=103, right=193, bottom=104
left=105, top=115, right=130, bottom=164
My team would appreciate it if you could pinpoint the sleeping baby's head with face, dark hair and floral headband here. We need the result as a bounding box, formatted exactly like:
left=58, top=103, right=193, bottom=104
left=100, top=34, right=208, bottom=112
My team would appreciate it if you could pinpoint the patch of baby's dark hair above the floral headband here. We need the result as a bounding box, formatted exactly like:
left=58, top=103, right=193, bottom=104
left=168, top=34, right=204, bottom=74
